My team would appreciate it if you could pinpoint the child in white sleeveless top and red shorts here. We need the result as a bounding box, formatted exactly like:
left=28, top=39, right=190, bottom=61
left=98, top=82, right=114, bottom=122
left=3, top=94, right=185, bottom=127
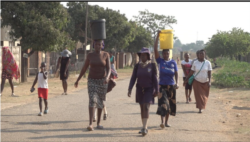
left=31, top=62, right=49, bottom=116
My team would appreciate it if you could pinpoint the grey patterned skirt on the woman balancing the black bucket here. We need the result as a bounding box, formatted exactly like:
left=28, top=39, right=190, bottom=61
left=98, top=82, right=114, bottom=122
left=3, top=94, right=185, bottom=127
left=88, top=78, right=108, bottom=108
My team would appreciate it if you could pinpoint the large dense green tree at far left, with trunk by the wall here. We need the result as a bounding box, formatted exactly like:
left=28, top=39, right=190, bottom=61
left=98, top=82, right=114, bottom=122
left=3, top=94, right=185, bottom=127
left=0, top=2, right=70, bottom=82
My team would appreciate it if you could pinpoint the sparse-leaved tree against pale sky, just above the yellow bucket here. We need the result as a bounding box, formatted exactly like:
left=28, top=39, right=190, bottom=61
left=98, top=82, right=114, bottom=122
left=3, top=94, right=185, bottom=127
left=133, top=9, right=177, bottom=39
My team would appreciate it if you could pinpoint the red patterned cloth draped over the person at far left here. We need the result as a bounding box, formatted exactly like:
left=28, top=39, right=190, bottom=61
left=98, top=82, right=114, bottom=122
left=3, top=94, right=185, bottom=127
left=2, top=46, right=20, bottom=80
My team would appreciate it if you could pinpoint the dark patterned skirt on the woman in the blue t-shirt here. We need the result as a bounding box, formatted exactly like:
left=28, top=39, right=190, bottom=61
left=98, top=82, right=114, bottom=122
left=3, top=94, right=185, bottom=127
left=156, top=85, right=176, bottom=116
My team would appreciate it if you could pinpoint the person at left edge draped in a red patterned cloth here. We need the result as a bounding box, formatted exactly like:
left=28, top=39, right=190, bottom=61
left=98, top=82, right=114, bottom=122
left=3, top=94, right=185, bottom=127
left=0, top=46, right=20, bottom=97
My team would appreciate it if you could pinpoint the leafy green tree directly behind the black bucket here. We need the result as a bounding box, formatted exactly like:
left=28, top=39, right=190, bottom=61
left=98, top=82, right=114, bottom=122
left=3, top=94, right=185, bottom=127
left=67, top=2, right=135, bottom=51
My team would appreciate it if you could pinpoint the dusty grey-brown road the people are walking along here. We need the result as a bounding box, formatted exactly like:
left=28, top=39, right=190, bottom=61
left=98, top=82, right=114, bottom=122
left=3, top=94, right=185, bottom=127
left=0, top=67, right=232, bottom=141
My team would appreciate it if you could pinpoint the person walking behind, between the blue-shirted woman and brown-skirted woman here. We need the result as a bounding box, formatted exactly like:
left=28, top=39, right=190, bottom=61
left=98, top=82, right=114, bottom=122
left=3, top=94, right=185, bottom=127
left=181, top=53, right=192, bottom=103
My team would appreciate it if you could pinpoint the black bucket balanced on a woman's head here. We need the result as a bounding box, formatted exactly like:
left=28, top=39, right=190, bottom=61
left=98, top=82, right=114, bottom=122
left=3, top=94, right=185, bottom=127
left=90, top=19, right=106, bottom=40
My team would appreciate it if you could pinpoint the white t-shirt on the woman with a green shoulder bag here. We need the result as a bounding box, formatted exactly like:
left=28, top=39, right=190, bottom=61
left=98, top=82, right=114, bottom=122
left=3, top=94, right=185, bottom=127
left=191, top=60, right=212, bottom=83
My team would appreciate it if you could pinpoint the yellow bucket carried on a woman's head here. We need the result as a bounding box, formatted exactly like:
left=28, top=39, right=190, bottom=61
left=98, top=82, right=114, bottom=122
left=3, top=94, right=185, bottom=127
left=159, top=30, right=174, bottom=49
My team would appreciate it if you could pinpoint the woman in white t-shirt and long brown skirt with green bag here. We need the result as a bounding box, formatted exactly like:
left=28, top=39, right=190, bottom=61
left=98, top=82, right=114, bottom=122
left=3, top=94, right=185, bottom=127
left=184, top=50, right=212, bottom=113
